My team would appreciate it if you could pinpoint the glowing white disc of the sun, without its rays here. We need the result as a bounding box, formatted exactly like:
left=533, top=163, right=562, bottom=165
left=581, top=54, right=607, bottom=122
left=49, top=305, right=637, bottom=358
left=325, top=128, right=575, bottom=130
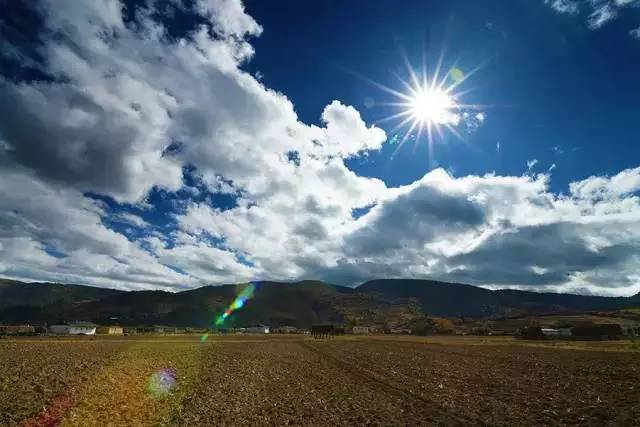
left=408, top=87, right=458, bottom=125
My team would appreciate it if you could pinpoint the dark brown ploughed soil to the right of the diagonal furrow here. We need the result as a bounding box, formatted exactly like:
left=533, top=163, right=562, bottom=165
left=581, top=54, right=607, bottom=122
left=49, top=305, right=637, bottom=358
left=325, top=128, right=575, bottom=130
left=312, top=340, right=640, bottom=426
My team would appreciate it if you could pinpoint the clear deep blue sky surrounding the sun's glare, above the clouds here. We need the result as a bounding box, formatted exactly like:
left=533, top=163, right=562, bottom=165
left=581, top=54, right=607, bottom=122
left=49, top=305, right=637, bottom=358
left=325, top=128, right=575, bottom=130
left=247, top=1, right=640, bottom=192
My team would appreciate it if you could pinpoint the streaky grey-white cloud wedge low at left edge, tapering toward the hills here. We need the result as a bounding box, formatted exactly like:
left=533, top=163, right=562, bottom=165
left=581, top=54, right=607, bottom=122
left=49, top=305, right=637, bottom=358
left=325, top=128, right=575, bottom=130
left=0, top=165, right=197, bottom=288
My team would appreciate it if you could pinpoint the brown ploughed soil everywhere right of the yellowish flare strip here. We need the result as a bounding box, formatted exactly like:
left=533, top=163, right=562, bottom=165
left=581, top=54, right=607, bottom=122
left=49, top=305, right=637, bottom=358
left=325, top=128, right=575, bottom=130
left=176, top=339, right=640, bottom=425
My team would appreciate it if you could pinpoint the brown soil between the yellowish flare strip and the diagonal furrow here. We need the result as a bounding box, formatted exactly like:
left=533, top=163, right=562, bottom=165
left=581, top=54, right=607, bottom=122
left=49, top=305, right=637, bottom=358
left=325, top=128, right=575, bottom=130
left=176, top=340, right=469, bottom=425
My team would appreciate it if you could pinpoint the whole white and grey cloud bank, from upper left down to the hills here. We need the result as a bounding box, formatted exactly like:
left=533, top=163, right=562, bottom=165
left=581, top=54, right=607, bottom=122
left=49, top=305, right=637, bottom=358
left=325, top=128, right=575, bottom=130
left=0, top=0, right=640, bottom=295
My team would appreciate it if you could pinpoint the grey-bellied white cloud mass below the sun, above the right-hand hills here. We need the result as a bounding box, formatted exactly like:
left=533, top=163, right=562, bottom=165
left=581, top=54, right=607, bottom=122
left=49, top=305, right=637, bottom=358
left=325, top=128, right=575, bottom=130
left=322, top=169, right=640, bottom=294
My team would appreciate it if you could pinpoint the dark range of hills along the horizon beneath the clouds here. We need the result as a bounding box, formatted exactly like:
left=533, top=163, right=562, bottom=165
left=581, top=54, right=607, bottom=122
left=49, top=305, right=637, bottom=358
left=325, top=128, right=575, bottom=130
left=0, top=279, right=640, bottom=327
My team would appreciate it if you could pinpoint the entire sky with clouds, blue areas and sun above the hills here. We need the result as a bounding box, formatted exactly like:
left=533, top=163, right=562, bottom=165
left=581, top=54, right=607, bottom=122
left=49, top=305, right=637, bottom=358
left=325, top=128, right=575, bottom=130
left=0, top=0, right=640, bottom=295
